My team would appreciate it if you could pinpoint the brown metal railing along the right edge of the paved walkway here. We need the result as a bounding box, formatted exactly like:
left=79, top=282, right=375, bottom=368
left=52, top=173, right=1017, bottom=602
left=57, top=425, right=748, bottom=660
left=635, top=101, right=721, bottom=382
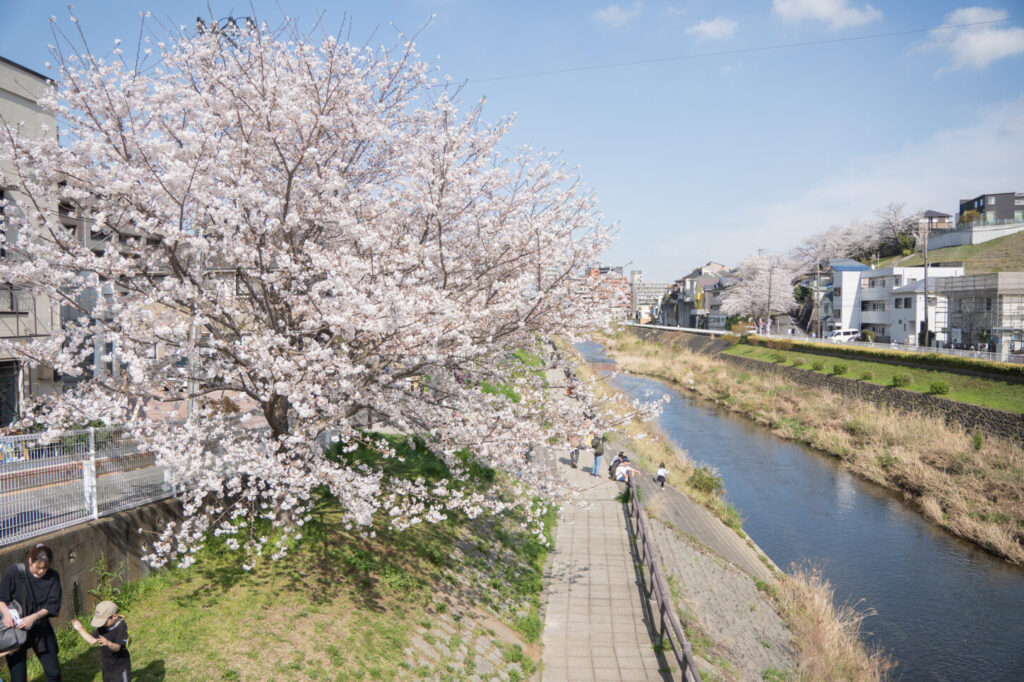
left=629, top=477, right=700, bottom=682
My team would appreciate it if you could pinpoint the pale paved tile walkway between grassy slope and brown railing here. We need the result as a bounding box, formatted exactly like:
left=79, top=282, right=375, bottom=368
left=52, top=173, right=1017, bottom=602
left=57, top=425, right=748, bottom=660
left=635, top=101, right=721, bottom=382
left=541, top=453, right=671, bottom=682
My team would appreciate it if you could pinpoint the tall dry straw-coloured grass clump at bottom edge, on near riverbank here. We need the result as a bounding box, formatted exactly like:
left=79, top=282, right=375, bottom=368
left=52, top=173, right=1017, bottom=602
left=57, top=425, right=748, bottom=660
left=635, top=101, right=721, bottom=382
left=777, top=568, right=894, bottom=682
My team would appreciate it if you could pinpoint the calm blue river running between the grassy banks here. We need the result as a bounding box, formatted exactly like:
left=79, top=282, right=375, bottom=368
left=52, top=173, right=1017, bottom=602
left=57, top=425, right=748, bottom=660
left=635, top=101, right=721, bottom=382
left=577, top=342, right=1024, bottom=680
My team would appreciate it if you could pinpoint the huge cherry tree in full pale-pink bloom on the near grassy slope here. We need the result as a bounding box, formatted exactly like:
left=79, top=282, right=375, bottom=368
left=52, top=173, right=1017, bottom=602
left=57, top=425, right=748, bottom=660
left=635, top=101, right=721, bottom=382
left=0, top=14, right=630, bottom=564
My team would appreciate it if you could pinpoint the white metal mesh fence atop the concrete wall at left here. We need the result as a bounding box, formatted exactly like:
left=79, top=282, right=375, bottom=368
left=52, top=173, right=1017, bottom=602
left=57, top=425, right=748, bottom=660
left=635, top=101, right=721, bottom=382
left=0, top=427, right=174, bottom=546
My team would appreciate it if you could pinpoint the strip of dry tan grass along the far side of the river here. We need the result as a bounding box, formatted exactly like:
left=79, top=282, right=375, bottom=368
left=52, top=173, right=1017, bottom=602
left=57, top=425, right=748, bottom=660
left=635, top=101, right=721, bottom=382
left=604, top=332, right=1024, bottom=564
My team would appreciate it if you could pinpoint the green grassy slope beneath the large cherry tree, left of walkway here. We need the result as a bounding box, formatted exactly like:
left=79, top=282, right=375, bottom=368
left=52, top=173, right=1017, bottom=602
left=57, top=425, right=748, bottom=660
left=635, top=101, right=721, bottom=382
left=30, top=436, right=555, bottom=682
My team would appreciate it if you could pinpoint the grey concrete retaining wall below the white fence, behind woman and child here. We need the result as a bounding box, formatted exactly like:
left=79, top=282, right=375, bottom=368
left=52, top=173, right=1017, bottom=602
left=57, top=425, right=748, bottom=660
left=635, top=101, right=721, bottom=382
left=0, top=500, right=181, bottom=625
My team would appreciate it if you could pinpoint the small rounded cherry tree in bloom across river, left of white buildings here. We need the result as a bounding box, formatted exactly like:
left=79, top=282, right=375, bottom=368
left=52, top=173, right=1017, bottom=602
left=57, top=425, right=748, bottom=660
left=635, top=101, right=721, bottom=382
left=722, top=251, right=797, bottom=319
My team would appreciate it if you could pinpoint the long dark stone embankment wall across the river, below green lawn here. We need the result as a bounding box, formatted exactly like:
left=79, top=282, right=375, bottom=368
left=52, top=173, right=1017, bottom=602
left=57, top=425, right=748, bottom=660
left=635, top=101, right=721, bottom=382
left=642, top=330, right=1024, bottom=443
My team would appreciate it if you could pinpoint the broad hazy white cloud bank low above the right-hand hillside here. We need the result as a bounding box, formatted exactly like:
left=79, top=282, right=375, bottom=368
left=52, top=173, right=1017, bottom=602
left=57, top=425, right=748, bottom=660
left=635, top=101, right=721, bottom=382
left=718, top=96, right=1024, bottom=262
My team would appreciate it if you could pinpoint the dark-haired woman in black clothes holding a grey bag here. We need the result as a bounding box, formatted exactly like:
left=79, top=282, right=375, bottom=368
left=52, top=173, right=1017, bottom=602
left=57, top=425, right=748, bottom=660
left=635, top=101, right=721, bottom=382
left=0, top=543, right=63, bottom=682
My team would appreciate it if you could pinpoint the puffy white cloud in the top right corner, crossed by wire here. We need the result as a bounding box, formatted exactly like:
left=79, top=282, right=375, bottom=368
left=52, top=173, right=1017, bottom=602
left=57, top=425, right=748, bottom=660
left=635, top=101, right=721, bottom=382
left=926, top=7, right=1024, bottom=71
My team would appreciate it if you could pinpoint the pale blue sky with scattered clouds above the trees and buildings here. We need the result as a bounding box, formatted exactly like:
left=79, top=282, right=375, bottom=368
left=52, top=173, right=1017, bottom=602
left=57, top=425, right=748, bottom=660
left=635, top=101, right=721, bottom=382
left=0, top=0, right=1024, bottom=281
